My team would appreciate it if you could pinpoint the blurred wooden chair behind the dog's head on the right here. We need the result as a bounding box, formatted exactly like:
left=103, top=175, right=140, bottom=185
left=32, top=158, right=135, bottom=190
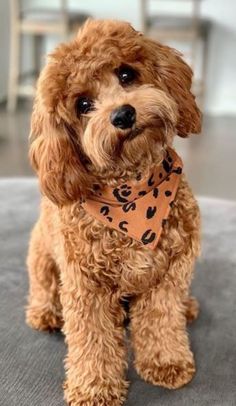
left=140, top=0, right=211, bottom=107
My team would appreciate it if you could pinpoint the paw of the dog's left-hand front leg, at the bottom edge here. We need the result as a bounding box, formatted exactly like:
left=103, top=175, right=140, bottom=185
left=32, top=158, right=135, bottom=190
left=64, top=382, right=128, bottom=406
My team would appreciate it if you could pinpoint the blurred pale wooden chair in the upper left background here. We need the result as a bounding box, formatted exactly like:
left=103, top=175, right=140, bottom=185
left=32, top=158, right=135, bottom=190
left=7, top=0, right=89, bottom=112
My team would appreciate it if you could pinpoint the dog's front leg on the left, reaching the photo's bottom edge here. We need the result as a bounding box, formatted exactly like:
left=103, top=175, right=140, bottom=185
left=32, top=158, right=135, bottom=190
left=61, top=268, right=128, bottom=406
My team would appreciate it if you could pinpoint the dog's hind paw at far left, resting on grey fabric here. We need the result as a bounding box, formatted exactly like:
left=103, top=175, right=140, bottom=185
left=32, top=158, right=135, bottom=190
left=26, top=307, right=63, bottom=331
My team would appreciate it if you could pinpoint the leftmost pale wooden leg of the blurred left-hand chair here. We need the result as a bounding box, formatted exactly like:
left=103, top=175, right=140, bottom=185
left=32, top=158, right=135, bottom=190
left=7, top=29, right=21, bottom=113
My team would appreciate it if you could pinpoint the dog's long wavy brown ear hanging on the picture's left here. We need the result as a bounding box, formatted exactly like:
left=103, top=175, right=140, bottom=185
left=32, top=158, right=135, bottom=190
left=29, top=96, right=88, bottom=206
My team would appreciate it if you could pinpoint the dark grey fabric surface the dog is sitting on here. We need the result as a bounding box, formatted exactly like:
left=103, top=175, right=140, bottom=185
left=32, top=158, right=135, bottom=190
left=0, top=179, right=236, bottom=406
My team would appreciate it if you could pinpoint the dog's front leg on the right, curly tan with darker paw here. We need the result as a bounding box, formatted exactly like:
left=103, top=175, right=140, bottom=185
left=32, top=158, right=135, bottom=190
left=131, top=281, right=195, bottom=389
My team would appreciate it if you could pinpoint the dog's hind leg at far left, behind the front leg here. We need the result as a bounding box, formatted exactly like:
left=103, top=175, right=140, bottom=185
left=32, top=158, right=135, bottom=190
left=26, top=225, right=62, bottom=331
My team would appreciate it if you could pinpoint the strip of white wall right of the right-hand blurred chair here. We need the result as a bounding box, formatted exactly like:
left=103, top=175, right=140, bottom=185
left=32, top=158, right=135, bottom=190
left=202, top=0, right=236, bottom=114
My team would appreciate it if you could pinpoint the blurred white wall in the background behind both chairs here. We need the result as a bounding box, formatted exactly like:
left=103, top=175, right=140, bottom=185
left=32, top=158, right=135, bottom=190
left=0, top=0, right=236, bottom=115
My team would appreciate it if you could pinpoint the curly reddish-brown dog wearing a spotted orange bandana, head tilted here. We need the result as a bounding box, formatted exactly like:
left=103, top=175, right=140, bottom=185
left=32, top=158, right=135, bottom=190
left=27, top=21, right=201, bottom=406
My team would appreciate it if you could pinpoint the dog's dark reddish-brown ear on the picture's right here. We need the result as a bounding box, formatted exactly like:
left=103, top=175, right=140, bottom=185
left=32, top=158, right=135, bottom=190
left=144, top=38, right=202, bottom=137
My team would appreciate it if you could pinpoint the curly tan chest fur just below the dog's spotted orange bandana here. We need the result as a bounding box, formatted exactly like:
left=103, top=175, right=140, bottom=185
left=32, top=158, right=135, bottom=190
left=57, top=179, right=199, bottom=294
